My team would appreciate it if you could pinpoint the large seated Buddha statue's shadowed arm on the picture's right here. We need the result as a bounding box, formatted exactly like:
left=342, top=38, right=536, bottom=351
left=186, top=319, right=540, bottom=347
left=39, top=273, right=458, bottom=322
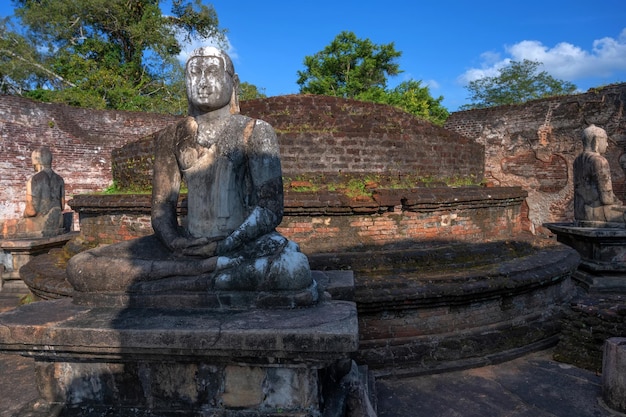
left=217, top=121, right=283, bottom=254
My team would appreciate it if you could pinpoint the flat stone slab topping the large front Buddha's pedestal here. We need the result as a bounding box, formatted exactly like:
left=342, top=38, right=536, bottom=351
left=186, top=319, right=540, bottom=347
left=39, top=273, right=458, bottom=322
left=0, top=299, right=358, bottom=362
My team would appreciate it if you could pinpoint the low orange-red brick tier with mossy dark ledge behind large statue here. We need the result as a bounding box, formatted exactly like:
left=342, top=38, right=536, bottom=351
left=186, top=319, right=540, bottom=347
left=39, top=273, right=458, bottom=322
left=70, top=187, right=526, bottom=254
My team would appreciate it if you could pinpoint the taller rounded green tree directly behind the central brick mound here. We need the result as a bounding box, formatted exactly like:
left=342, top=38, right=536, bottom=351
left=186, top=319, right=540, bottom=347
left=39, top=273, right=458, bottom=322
left=297, top=32, right=402, bottom=98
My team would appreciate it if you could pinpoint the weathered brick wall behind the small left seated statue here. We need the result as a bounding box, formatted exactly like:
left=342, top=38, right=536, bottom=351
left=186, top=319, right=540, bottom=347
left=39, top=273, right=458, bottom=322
left=0, top=96, right=175, bottom=220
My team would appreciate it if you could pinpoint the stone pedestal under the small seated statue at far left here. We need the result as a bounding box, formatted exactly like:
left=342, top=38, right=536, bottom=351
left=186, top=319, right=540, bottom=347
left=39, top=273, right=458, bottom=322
left=0, top=232, right=77, bottom=291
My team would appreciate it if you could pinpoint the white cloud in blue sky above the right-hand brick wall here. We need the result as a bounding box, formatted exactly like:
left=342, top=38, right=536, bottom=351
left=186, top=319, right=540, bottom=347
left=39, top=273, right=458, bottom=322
left=459, top=29, right=626, bottom=84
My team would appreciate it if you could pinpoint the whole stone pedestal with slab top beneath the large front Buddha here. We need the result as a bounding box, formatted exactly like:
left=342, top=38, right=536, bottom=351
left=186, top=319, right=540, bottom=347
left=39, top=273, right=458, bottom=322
left=0, top=299, right=358, bottom=417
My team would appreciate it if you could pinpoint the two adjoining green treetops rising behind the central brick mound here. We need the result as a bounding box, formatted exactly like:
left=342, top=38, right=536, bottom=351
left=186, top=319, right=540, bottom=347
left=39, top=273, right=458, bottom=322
left=297, top=32, right=449, bottom=125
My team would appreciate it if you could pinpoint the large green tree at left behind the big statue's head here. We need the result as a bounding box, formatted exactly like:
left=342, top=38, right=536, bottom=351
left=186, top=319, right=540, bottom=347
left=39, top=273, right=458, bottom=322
left=3, top=0, right=224, bottom=113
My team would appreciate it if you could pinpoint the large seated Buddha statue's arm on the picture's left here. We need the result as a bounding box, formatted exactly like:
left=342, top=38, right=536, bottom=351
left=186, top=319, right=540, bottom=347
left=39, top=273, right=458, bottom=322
left=151, top=122, right=181, bottom=249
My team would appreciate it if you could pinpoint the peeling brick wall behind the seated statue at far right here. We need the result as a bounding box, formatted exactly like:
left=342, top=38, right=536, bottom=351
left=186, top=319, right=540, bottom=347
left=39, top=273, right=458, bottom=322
left=445, top=84, right=626, bottom=232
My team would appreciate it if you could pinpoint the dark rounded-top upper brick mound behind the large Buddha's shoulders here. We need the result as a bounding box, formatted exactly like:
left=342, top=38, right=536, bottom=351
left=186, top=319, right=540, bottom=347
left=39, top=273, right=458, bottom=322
left=113, top=95, right=484, bottom=188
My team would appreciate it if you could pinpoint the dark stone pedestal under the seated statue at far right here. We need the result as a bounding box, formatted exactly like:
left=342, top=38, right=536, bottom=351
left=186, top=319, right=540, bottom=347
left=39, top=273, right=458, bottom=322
left=544, top=222, right=626, bottom=294
